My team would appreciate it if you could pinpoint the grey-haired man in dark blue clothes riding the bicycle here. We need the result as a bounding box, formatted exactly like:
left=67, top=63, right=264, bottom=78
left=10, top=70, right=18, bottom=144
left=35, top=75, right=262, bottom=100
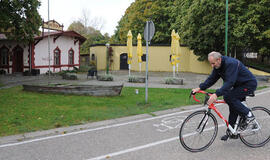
left=192, top=52, right=257, bottom=140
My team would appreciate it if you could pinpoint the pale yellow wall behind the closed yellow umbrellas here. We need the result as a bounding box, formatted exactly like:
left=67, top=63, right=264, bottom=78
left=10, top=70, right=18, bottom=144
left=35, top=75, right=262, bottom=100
left=90, top=45, right=270, bottom=75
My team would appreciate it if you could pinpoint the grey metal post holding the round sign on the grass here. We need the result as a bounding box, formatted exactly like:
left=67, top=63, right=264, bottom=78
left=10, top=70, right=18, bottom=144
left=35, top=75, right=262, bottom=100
left=145, top=21, right=150, bottom=103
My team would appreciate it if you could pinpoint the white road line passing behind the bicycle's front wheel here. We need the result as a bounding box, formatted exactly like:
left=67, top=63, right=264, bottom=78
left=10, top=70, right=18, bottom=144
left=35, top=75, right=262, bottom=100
left=87, top=124, right=225, bottom=160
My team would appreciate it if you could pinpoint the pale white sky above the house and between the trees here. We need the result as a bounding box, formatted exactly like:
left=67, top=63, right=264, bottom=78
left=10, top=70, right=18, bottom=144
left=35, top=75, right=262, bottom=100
left=38, top=0, right=135, bottom=36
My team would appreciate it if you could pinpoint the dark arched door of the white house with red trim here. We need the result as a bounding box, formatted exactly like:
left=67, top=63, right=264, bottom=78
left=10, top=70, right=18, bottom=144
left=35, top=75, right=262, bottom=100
left=12, top=46, right=23, bottom=73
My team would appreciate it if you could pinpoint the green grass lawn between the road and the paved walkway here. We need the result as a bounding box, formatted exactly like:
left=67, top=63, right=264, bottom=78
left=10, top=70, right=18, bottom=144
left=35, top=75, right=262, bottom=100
left=0, top=86, right=266, bottom=136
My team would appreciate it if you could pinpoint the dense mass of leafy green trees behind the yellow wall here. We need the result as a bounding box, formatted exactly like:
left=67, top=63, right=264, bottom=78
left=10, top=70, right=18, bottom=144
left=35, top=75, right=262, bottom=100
left=111, top=0, right=270, bottom=60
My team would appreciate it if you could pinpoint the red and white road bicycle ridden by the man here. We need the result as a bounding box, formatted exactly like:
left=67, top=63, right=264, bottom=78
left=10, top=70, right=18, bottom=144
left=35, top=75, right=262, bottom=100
left=179, top=91, right=270, bottom=152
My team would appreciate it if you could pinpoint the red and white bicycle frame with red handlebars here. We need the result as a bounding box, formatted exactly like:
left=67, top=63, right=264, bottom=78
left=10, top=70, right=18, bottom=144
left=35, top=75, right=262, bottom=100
left=192, top=90, right=240, bottom=135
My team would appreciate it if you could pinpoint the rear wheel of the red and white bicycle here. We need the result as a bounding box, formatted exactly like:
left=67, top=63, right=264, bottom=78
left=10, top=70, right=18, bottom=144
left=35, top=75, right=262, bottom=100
left=240, top=107, right=270, bottom=148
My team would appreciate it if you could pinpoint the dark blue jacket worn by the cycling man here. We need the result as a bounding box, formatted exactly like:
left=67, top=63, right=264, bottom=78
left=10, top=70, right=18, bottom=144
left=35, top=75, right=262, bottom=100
left=199, top=56, right=257, bottom=96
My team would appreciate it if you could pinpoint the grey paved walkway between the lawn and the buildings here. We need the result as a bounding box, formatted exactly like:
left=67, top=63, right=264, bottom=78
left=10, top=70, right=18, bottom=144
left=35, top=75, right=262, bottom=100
left=0, top=71, right=270, bottom=89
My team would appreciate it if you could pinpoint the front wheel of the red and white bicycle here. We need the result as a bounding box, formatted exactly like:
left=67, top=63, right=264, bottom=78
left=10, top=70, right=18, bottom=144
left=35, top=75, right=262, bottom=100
left=179, top=111, right=218, bottom=152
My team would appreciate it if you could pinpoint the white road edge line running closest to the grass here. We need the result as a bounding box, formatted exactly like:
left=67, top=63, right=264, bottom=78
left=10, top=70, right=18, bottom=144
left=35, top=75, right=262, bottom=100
left=0, top=90, right=270, bottom=148
